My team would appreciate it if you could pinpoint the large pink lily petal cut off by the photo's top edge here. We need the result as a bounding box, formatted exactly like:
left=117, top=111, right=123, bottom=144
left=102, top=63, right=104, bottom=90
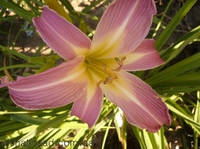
left=92, top=0, right=156, bottom=56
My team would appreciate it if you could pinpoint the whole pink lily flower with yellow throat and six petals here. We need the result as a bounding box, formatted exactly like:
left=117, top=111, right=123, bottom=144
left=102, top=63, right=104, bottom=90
left=1, top=0, right=170, bottom=132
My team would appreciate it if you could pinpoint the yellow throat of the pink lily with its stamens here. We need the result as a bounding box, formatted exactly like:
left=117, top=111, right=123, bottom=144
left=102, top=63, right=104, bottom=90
left=85, top=56, right=126, bottom=84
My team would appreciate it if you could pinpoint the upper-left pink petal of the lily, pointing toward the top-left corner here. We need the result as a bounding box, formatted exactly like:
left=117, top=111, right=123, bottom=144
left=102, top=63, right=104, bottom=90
left=33, top=7, right=91, bottom=59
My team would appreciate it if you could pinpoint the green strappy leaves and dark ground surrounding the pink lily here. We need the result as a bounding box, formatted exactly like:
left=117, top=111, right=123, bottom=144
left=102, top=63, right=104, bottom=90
left=0, top=0, right=200, bottom=149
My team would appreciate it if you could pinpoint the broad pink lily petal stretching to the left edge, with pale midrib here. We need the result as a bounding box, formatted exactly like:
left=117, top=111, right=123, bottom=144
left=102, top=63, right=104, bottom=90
left=8, top=59, right=86, bottom=110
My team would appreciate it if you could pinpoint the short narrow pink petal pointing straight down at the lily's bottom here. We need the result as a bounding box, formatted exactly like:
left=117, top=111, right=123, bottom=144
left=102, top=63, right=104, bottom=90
left=71, top=84, right=103, bottom=128
